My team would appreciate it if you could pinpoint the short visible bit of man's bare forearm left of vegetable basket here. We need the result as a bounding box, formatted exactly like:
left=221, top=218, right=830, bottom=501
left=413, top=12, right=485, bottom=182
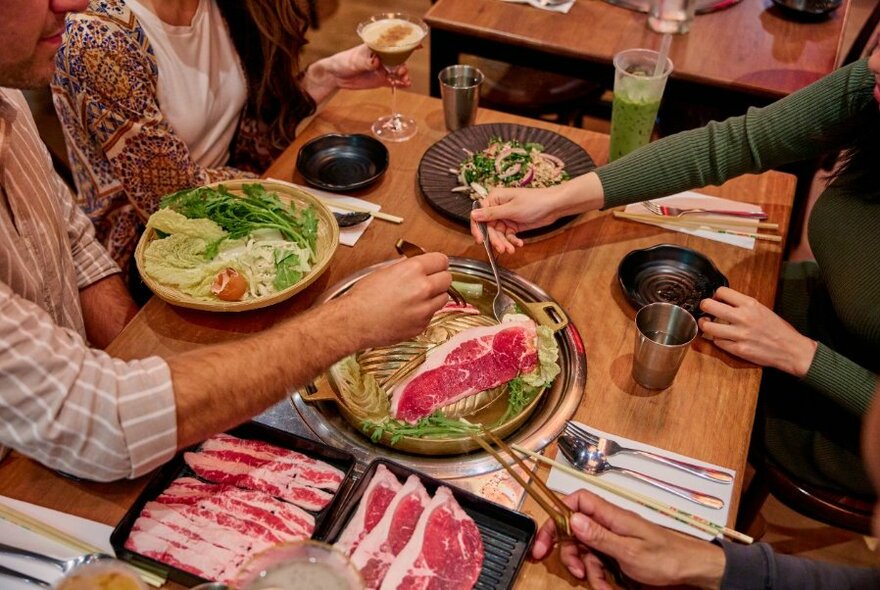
left=79, top=274, right=138, bottom=348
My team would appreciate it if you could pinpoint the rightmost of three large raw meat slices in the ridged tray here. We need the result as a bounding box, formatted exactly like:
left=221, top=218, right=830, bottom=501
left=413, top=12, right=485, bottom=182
left=382, top=487, right=483, bottom=590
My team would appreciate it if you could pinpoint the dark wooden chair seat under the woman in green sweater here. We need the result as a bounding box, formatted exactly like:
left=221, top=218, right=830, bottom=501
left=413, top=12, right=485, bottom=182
left=736, top=453, right=876, bottom=535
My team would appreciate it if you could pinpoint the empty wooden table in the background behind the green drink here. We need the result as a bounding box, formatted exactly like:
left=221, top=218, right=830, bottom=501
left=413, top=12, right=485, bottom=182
left=424, top=0, right=849, bottom=112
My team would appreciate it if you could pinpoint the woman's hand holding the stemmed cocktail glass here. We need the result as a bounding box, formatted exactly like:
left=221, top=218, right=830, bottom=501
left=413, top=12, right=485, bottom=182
left=303, top=45, right=412, bottom=102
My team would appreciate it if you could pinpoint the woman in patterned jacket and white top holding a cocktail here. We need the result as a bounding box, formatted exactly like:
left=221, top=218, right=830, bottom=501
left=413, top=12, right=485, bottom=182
left=52, top=0, right=402, bottom=278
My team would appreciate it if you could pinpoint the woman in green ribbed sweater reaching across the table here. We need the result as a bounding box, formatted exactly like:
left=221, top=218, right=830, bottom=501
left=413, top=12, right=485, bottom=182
left=472, top=51, right=880, bottom=495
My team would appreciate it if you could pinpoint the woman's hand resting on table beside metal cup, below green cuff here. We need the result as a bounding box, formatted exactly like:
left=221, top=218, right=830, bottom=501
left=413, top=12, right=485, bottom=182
left=700, top=287, right=817, bottom=378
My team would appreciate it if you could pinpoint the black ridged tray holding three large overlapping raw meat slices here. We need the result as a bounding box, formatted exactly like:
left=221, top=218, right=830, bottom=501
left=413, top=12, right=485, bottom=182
left=323, top=459, right=536, bottom=590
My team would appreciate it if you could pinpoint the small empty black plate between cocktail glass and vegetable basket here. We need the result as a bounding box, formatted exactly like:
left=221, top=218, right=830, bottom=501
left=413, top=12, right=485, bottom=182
left=296, top=133, right=388, bottom=192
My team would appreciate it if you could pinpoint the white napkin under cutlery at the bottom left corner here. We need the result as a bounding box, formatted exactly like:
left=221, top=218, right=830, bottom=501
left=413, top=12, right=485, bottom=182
left=0, top=496, right=113, bottom=590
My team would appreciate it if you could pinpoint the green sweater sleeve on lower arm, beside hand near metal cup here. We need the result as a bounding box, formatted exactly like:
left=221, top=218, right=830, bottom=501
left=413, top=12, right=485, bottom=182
left=803, top=342, right=877, bottom=416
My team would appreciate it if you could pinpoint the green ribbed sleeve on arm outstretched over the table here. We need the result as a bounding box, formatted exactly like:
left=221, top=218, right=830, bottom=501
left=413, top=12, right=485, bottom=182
left=596, top=59, right=874, bottom=208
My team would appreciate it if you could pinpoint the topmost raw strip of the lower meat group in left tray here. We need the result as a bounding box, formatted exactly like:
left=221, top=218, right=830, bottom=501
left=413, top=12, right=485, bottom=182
left=156, top=477, right=315, bottom=538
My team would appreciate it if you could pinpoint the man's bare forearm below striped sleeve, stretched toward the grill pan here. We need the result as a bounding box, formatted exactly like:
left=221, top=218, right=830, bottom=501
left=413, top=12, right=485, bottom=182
left=168, top=300, right=360, bottom=448
